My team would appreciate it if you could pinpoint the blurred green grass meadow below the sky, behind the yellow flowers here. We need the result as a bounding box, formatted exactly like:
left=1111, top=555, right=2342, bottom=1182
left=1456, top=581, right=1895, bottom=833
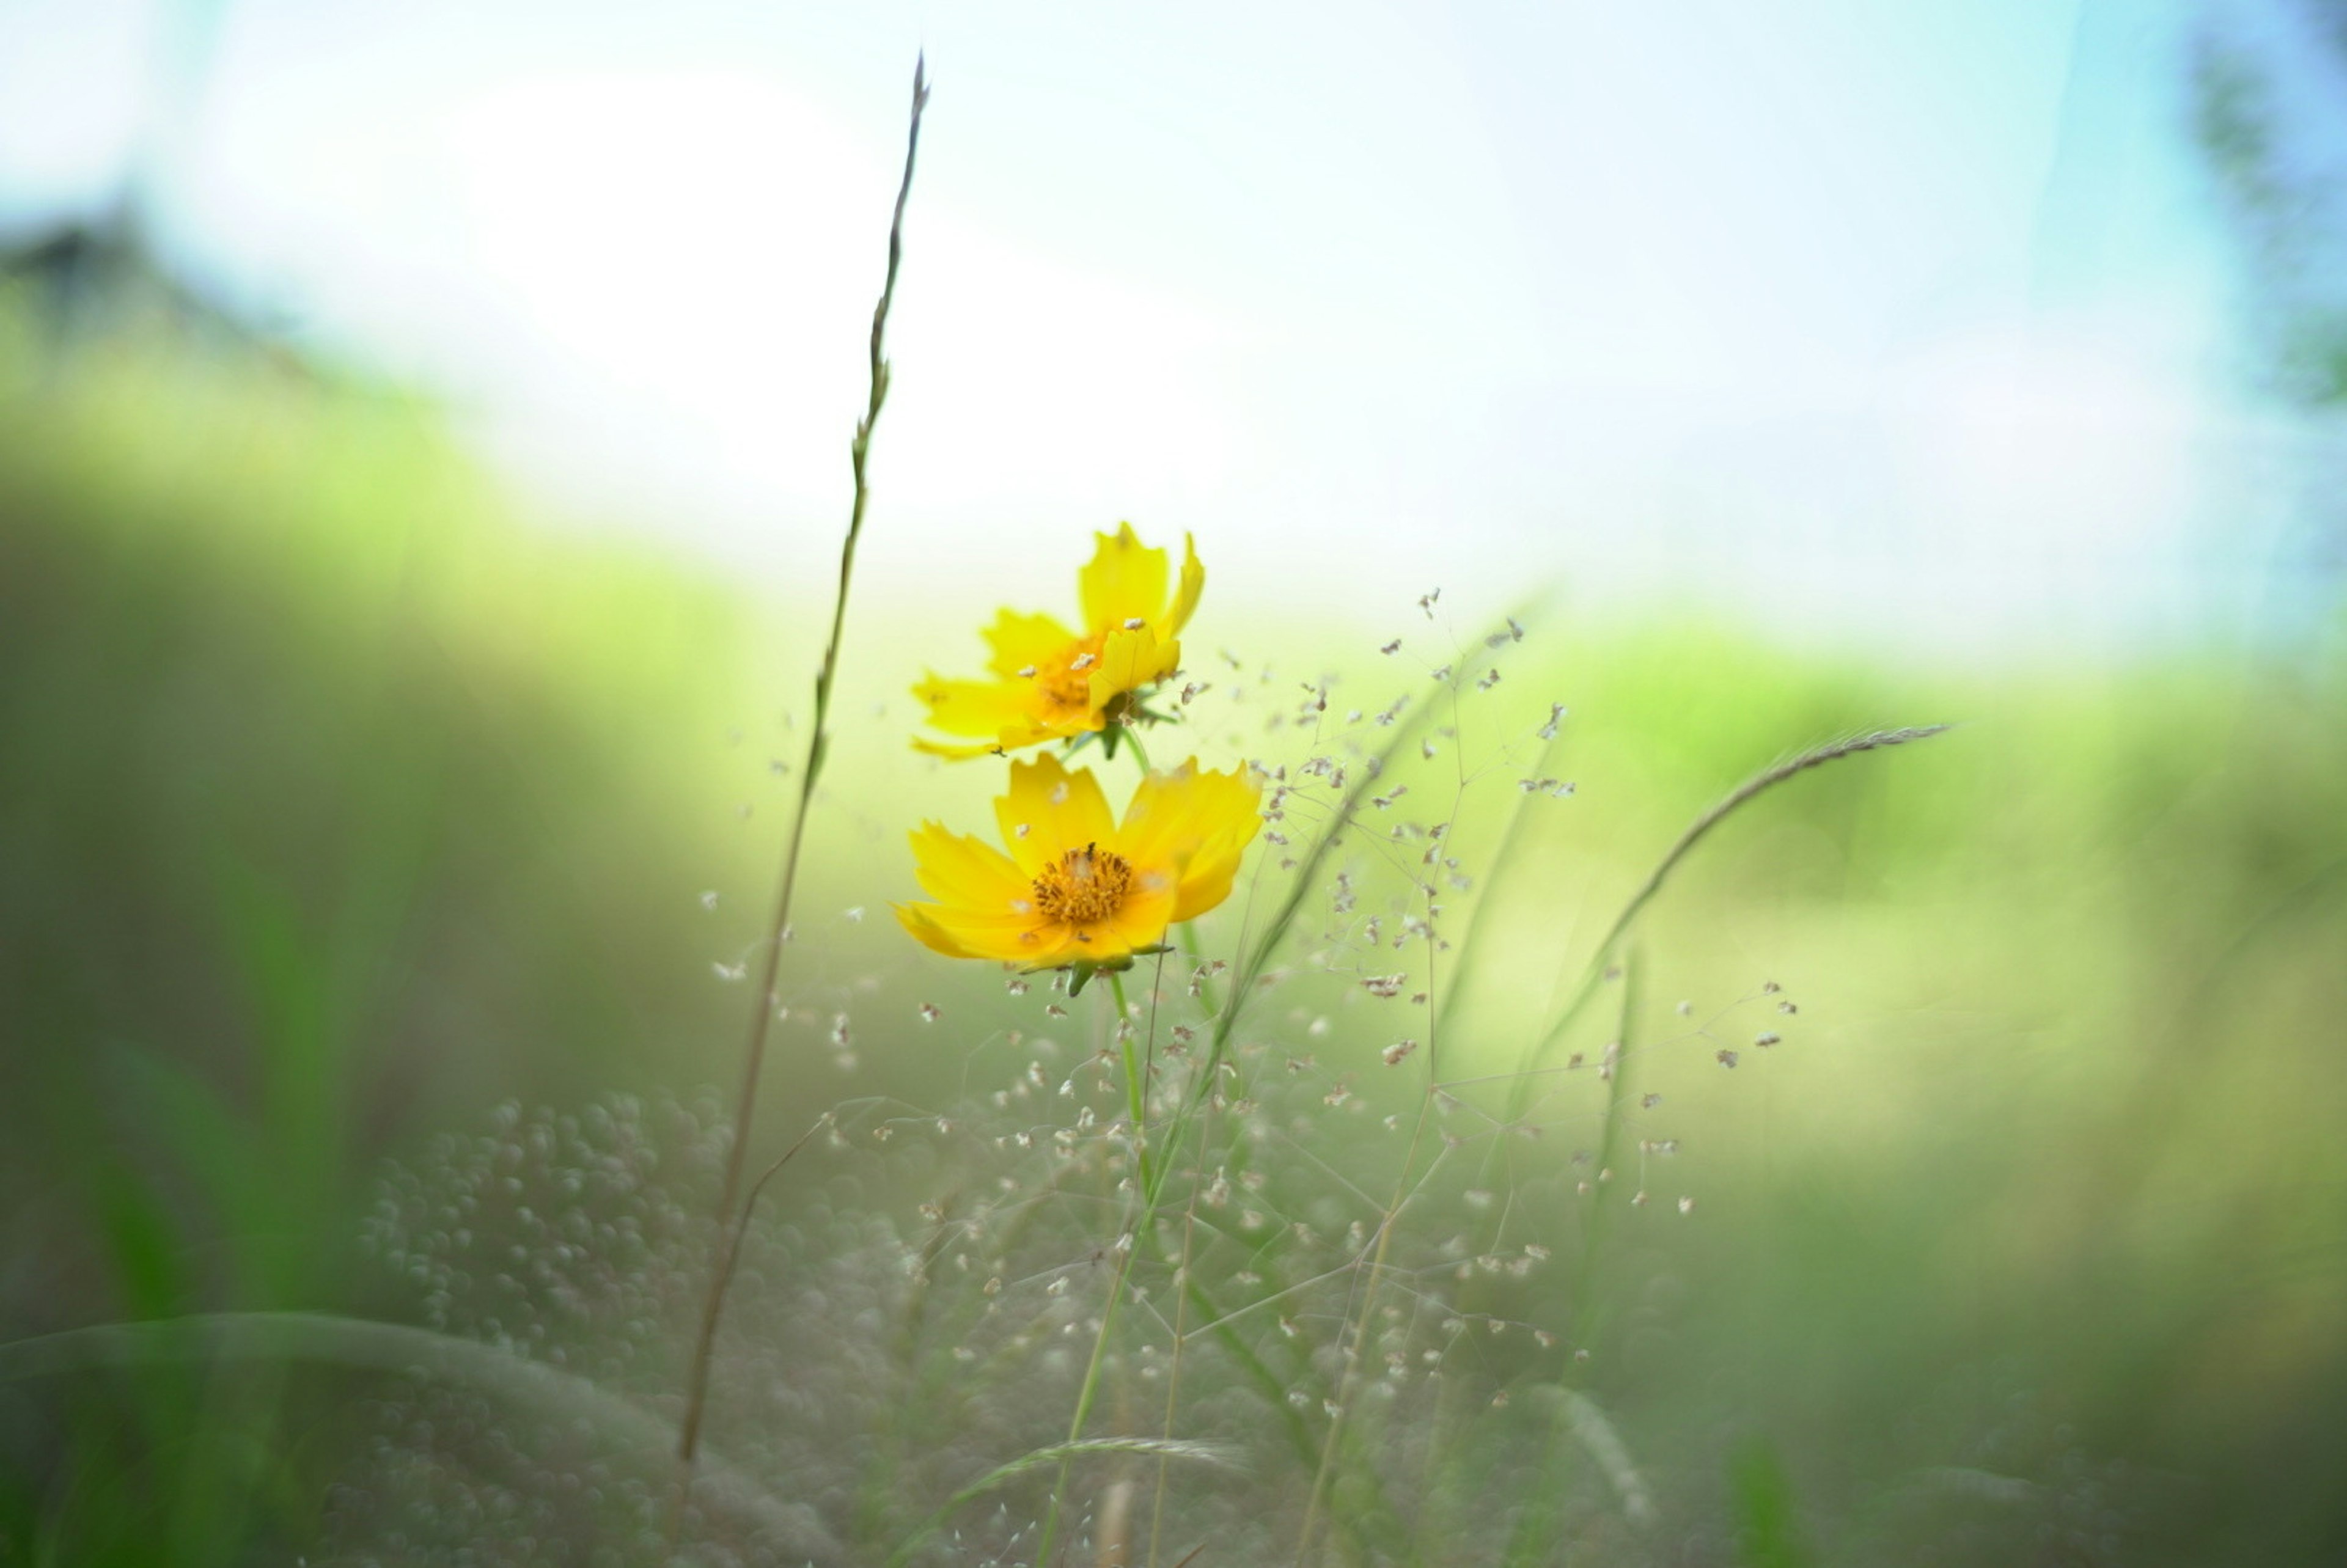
left=0, top=300, right=2347, bottom=1563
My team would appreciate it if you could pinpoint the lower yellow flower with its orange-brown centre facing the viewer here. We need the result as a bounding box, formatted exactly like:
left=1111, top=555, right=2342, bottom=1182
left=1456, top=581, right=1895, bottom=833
left=897, top=756, right=1263, bottom=969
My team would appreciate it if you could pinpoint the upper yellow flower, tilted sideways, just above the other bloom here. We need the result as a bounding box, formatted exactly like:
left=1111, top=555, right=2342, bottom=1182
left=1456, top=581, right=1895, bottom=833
left=913, top=524, right=1207, bottom=756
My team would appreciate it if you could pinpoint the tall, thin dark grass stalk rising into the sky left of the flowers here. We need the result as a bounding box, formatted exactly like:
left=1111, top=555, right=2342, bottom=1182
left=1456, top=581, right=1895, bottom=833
left=669, top=59, right=930, bottom=1552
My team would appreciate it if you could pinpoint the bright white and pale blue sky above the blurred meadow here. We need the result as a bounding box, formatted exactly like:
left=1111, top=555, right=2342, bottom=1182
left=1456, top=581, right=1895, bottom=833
left=0, top=0, right=2337, bottom=650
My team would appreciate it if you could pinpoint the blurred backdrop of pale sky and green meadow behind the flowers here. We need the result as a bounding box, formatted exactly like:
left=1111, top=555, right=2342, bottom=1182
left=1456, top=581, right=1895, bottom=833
left=0, top=0, right=2347, bottom=1568
